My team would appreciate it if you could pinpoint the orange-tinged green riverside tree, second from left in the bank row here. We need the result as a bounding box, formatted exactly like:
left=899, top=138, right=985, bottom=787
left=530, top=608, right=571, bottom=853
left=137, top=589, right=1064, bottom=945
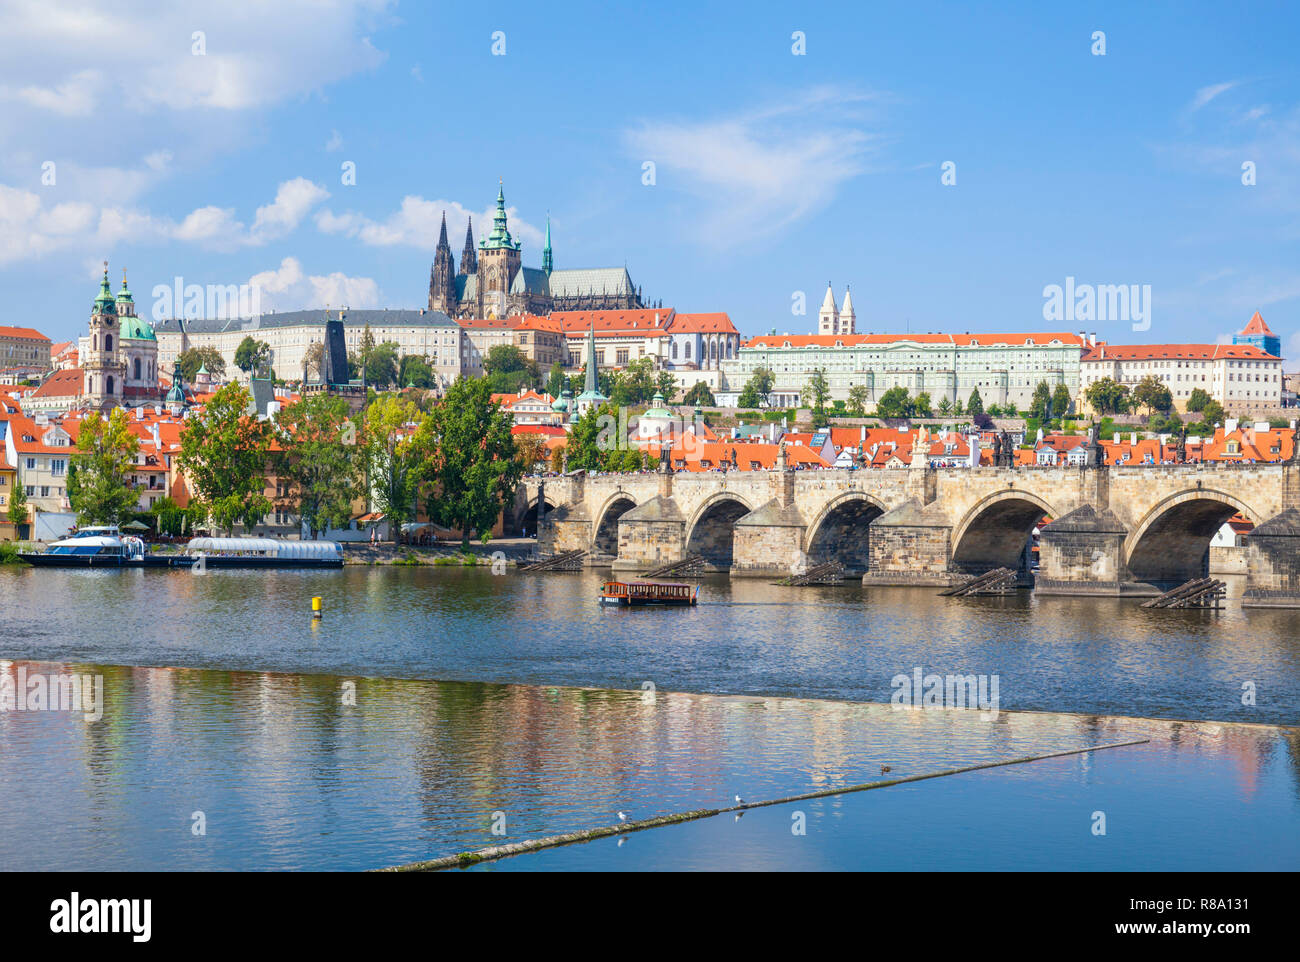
left=179, top=384, right=273, bottom=532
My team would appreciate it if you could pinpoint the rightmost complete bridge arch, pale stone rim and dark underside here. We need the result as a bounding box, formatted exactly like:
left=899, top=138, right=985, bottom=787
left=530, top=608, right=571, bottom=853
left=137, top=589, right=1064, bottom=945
left=1125, top=489, right=1264, bottom=586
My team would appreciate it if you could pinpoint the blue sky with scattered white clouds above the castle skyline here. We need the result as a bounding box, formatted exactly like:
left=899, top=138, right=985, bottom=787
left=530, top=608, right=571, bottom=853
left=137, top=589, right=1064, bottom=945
left=0, top=0, right=1300, bottom=358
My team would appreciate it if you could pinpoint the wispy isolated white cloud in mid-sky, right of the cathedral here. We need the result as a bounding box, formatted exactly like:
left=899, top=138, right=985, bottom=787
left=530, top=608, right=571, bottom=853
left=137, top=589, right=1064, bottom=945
left=624, top=87, right=880, bottom=246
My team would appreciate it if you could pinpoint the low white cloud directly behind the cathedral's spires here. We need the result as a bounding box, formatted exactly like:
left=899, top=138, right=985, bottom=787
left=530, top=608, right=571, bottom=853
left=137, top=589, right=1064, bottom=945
left=316, top=195, right=543, bottom=248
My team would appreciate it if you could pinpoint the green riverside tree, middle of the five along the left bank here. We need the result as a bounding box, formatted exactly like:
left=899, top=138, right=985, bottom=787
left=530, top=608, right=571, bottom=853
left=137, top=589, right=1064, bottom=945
left=277, top=394, right=363, bottom=538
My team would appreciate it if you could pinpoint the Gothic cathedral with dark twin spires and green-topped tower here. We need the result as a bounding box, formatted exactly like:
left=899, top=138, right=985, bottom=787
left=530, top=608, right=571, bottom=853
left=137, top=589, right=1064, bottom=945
left=429, top=187, right=653, bottom=319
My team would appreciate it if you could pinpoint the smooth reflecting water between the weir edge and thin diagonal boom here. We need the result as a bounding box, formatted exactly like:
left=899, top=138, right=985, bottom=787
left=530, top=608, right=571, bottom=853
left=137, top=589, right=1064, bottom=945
left=0, top=663, right=1300, bottom=868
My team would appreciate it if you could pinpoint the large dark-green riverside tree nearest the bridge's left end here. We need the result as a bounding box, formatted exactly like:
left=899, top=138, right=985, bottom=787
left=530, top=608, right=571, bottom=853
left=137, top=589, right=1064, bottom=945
left=421, top=377, right=523, bottom=543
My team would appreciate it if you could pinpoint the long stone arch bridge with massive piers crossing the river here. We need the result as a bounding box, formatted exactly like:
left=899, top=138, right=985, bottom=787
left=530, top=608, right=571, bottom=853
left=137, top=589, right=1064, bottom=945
left=515, top=463, right=1300, bottom=606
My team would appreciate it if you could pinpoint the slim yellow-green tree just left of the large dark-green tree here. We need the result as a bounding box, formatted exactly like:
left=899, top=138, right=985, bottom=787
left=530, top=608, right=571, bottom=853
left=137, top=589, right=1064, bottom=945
left=360, top=394, right=426, bottom=541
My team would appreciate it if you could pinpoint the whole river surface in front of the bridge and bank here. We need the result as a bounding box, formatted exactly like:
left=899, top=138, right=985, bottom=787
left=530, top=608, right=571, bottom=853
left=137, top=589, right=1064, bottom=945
left=0, top=567, right=1300, bottom=868
